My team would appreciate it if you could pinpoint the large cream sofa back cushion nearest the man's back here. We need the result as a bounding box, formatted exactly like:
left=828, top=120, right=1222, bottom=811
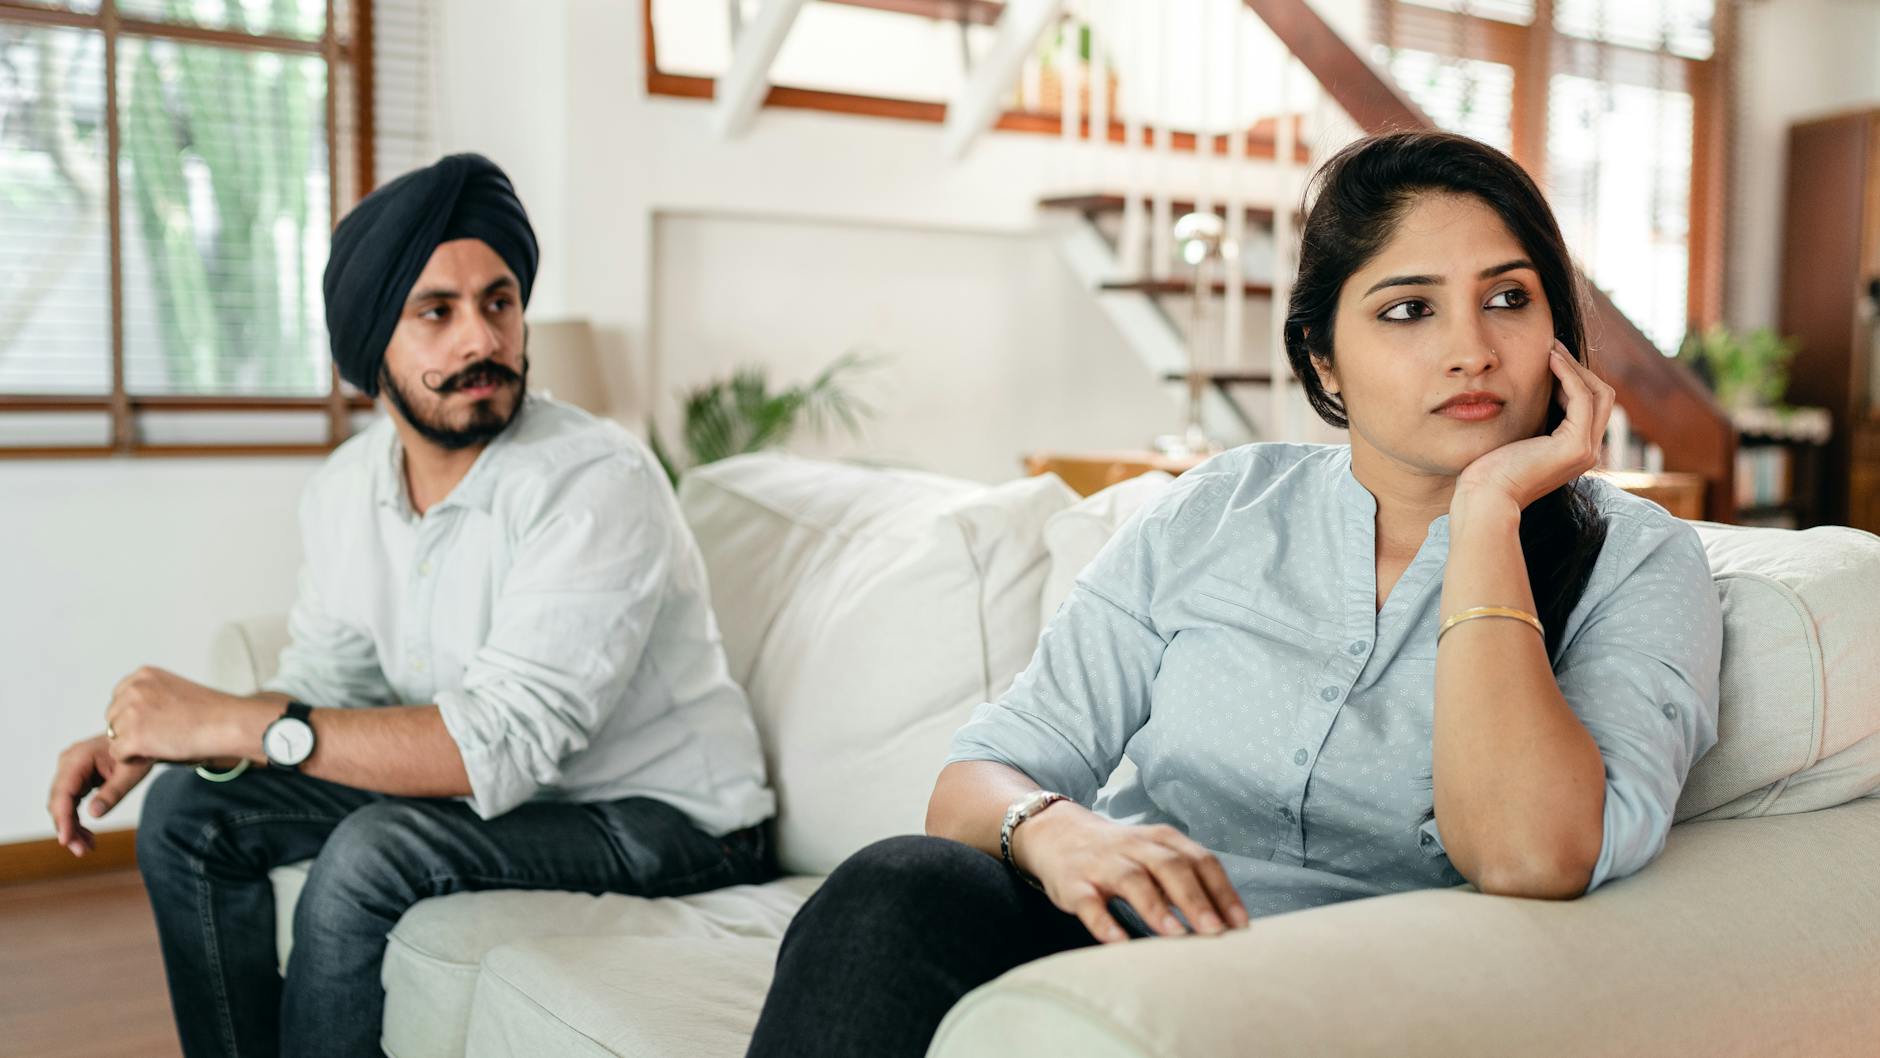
left=681, top=453, right=1075, bottom=874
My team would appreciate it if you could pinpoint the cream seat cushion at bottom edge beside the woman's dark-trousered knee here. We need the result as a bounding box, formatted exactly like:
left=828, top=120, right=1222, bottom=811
left=466, top=938, right=778, bottom=1058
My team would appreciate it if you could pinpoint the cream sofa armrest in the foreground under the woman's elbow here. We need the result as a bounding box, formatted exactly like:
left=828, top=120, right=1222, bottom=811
left=929, top=797, right=1880, bottom=1058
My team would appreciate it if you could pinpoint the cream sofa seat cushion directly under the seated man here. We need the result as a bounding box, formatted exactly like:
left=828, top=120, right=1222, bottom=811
left=271, top=863, right=822, bottom=1058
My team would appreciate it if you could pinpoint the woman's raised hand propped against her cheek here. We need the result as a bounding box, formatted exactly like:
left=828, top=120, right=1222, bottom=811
left=1451, top=340, right=1613, bottom=511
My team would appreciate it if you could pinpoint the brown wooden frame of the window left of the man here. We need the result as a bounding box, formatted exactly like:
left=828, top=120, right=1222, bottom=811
left=0, top=0, right=374, bottom=459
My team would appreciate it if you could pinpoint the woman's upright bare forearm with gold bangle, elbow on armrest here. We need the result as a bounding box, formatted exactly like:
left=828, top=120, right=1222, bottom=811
left=1433, top=500, right=1606, bottom=896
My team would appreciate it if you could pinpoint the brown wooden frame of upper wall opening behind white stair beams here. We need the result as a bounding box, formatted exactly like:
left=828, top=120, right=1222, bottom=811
left=639, top=0, right=1312, bottom=165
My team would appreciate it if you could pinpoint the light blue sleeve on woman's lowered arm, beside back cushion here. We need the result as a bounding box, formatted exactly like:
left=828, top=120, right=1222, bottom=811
left=946, top=483, right=1188, bottom=804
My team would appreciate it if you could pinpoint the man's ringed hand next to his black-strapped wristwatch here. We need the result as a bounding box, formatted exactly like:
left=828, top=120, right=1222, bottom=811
left=105, top=665, right=278, bottom=765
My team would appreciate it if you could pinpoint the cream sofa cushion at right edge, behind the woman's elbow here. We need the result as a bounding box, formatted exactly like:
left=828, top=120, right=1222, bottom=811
left=1677, top=522, right=1880, bottom=821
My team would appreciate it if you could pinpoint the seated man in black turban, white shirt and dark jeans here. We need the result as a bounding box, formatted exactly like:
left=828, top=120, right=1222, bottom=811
left=49, top=154, right=776, bottom=1056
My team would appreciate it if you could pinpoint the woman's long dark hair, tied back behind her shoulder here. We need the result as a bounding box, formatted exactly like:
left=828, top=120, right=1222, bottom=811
left=1286, top=132, right=1606, bottom=658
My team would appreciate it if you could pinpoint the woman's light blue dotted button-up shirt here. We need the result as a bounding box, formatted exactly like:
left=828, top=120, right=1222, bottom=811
left=948, top=443, right=1722, bottom=915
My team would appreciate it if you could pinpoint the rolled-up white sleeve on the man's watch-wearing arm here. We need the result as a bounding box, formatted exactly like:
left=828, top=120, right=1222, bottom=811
left=436, top=459, right=677, bottom=819
